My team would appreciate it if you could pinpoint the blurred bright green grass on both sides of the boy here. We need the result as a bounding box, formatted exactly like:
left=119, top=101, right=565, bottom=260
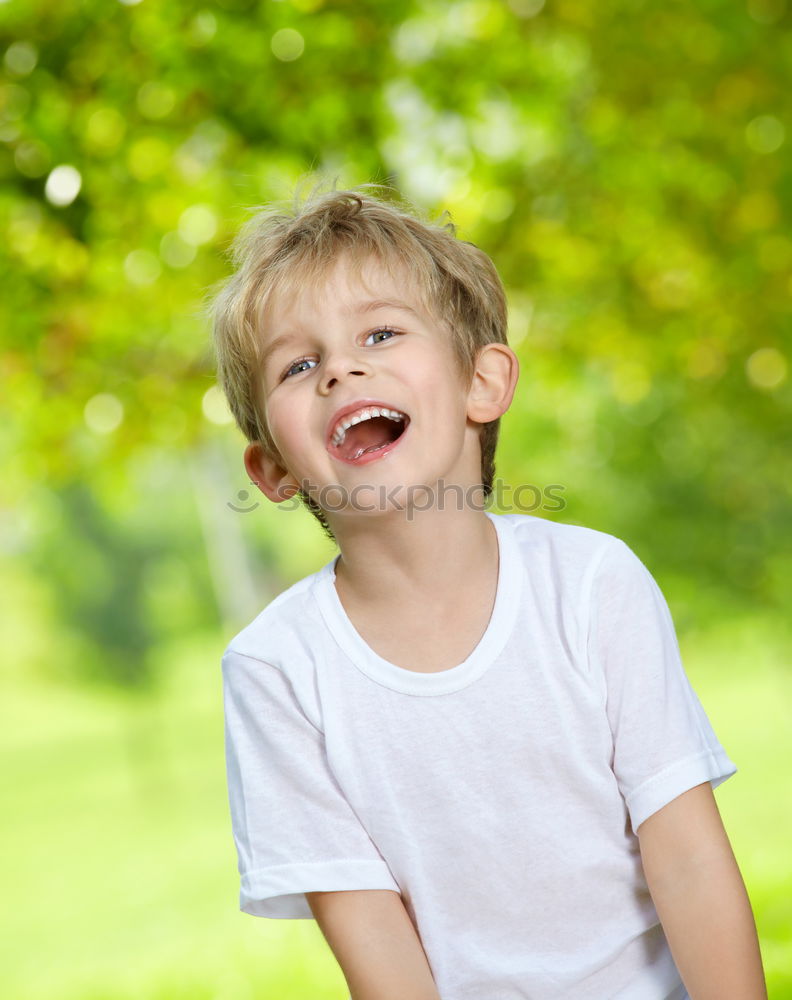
left=0, top=619, right=792, bottom=1000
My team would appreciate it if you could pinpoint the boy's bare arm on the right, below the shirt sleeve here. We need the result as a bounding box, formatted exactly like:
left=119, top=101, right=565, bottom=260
left=637, top=782, right=767, bottom=1000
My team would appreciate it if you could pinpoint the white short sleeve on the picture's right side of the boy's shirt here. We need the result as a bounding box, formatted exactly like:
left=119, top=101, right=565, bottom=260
left=589, top=538, right=737, bottom=831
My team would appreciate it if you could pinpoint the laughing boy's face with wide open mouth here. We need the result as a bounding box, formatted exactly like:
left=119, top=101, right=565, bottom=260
left=252, top=258, right=488, bottom=513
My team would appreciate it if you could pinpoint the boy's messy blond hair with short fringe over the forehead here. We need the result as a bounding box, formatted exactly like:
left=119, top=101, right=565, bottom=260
left=211, top=184, right=507, bottom=538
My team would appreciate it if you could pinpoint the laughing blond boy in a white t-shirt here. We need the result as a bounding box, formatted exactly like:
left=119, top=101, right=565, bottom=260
left=210, top=191, right=766, bottom=1000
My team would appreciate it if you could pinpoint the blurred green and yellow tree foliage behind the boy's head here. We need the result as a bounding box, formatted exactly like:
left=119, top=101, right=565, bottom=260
left=0, top=0, right=792, bottom=673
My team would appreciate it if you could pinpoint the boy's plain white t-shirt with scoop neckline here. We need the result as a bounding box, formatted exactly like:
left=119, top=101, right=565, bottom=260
left=223, top=513, right=737, bottom=1000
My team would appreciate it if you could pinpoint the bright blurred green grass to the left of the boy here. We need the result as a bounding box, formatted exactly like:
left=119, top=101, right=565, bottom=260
left=0, top=638, right=348, bottom=1000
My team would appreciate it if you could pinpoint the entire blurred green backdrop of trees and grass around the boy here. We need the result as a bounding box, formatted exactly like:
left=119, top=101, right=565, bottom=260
left=0, top=0, right=792, bottom=1000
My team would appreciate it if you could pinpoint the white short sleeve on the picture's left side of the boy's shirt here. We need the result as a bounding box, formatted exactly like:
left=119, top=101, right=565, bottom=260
left=223, top=650, right=399, bottom=918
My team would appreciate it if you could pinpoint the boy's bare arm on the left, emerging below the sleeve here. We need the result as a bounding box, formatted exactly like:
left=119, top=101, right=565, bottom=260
left=305, top=889, right=440, bottom=1000
